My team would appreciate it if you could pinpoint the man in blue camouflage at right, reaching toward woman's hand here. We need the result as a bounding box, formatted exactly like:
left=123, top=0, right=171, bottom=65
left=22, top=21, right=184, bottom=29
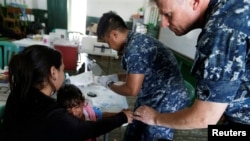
left=135, top=0, right=250, bottom=129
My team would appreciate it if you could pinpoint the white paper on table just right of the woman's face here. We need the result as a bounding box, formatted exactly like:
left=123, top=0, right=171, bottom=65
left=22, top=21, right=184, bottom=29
left=69, top=71, right=94, bottom=86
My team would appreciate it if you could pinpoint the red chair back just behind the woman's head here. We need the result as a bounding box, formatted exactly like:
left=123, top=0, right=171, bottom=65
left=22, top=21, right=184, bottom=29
left=54, top=44, right=78, bottom=73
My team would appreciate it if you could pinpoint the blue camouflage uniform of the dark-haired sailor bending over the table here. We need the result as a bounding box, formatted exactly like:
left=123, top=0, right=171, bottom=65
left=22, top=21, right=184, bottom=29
left=121, top=31, right=190, bottom=141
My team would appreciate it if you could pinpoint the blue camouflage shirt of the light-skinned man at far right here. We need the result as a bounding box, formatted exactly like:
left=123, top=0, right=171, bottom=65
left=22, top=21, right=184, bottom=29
left=192, top=0, right=250, bottom=125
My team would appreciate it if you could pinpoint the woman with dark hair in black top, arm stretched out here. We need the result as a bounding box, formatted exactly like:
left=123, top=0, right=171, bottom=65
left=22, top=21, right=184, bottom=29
left=3, top=45, right=132, bottom=141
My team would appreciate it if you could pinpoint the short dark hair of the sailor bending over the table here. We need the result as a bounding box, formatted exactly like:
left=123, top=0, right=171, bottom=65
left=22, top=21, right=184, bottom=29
left=97, top=11, right=128, bottom=41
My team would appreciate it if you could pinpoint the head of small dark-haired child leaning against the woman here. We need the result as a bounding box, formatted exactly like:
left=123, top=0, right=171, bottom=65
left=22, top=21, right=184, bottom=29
left=57, top=84, right=85, bottom=109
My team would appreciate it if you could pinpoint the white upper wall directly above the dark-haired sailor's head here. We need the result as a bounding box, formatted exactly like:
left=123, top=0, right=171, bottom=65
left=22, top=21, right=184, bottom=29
left=87, top=0, right=145, bottom=21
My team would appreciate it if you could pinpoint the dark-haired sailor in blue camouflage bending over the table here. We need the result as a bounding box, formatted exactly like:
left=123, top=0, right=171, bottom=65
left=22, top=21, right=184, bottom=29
left=97, top=11, right=191, bottom=141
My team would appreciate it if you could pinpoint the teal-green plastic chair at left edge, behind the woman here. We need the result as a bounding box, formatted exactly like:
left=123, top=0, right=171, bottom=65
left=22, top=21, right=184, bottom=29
left=0, top=41, right=18, bottom=69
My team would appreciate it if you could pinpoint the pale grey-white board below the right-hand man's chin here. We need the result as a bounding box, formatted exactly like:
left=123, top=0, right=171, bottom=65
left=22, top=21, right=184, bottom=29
left=159, top=28, right=201, bottom=59
